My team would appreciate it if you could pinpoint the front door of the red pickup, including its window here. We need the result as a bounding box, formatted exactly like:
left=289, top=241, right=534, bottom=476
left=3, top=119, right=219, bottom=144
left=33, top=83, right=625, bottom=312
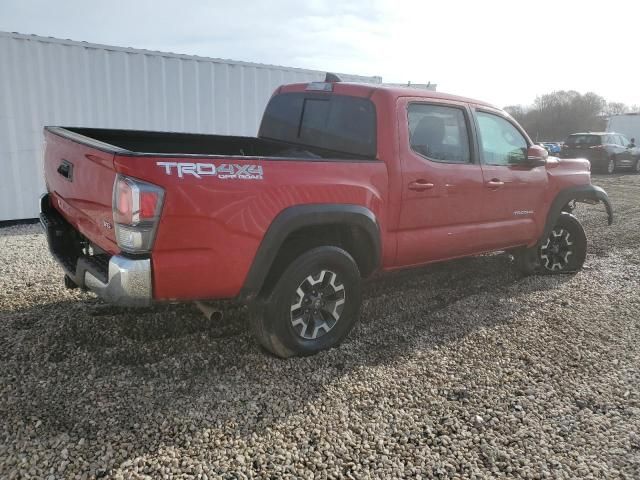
left=474, top=109, right=548, bottom=249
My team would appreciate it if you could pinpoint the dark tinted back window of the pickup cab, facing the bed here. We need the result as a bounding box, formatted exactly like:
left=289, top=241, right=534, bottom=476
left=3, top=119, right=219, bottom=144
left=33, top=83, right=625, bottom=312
left=259, top=93, right=376, bottom=158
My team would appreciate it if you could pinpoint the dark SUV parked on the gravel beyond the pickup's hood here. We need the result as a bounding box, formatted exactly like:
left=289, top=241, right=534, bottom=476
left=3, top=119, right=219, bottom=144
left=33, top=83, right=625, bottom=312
left=560, top=132, right=640, bottom=173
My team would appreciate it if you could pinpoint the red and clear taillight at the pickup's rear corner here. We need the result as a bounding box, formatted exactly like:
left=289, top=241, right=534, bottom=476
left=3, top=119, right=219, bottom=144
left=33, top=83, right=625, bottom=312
left=113, top=175, right=164, bottom=253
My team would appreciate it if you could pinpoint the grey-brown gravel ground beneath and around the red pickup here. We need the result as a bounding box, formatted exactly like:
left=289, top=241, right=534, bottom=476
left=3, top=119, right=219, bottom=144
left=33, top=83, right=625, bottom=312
left=0, top=175, right=640, bottom=479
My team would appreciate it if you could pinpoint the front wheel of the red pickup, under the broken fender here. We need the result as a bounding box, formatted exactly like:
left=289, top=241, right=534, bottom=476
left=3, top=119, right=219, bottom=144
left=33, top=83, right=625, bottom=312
left=514, top=212, right=587, bottom=274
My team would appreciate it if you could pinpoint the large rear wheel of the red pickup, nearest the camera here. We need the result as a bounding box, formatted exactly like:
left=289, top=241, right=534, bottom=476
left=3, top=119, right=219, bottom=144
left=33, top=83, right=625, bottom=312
left=251, top=246, right=362, bottom=358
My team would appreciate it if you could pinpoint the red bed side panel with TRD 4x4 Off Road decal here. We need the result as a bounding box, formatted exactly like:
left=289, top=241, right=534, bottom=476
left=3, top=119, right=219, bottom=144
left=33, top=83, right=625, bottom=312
left=115, top=156, right=388, bottom=300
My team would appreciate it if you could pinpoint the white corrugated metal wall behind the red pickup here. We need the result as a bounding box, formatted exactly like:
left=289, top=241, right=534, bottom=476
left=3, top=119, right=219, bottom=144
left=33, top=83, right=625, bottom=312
left=0, top=32, right=381, bottom=221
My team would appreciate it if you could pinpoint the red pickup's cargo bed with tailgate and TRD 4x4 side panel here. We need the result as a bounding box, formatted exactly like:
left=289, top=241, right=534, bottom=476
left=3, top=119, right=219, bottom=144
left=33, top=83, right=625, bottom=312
left=44, top=127, right=387, bottom=300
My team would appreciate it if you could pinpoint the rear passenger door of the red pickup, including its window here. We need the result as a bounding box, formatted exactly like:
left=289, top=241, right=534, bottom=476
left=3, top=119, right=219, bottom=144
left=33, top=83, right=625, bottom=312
left=396, top=98, right=484, bottom=266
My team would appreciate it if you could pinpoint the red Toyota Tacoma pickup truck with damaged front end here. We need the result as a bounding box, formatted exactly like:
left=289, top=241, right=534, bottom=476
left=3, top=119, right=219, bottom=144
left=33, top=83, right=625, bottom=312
left=41, top=79, right=613, bottom=357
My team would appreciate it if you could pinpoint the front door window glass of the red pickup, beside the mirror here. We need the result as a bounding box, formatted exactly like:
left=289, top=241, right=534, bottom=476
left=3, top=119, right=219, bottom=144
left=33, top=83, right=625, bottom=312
left=476, top=112, right=528, bottom=165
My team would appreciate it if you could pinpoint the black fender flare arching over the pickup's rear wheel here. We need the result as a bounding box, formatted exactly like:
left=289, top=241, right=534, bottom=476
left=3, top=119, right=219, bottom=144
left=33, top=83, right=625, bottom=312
left=239, top=204, right=382, bottom=300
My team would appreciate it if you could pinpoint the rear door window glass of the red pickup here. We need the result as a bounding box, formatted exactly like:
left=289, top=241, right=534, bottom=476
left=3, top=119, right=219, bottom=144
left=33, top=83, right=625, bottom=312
left=408, top=103, right=471, bottom=163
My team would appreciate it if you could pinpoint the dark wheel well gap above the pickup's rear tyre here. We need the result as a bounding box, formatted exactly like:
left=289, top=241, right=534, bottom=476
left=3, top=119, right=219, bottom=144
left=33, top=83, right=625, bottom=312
left=262, top=223, right=378, bottom=290
